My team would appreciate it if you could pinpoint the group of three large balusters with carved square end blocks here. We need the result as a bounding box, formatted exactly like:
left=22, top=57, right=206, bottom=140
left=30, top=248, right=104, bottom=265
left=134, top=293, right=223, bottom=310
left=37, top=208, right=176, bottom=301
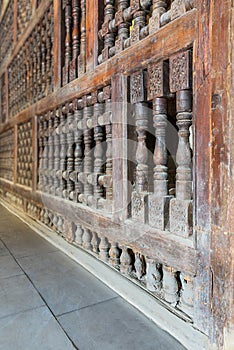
left=130, top=50, right=192, bottom=237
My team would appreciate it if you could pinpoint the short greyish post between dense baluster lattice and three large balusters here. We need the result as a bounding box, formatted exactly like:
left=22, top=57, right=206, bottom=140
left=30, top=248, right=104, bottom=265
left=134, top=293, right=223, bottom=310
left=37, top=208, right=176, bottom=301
left=112, top=74, right=131, bottom=222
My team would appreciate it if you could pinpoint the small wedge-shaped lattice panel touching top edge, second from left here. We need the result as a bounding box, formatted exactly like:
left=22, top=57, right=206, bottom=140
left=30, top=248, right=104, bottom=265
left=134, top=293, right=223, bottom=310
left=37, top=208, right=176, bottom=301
left=17, top=0, right=32, bottom=38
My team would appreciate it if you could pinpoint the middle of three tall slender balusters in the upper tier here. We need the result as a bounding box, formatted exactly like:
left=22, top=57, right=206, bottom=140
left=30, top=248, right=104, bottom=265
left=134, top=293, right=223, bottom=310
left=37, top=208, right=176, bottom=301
left=69, top=0, right=80, bottom=81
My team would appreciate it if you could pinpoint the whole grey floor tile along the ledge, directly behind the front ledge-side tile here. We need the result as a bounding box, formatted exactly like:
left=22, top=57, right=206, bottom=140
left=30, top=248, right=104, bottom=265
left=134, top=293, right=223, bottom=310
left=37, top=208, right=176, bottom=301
left=19, top=252, right=117, bottom=315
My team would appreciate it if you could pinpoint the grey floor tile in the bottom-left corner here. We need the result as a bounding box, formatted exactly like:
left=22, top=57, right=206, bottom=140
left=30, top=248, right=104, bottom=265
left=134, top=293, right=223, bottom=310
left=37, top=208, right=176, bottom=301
left=0, top=307, right=74, bottom=350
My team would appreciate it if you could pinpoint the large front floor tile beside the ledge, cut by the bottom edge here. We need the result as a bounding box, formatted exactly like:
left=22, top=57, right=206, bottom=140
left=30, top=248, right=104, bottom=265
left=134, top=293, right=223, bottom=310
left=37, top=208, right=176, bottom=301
left=59, top=297, right=185, bottom=350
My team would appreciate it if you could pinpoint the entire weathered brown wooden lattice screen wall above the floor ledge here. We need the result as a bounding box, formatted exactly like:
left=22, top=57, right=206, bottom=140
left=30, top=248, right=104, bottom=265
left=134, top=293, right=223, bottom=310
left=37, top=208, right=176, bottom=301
left=0, top=0, right=234, bottom=349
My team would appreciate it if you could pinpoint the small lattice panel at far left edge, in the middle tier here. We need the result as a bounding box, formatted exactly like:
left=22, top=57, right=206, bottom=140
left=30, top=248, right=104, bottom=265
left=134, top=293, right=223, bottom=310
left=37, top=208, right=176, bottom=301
left=0, top=129, right=14, bottom=181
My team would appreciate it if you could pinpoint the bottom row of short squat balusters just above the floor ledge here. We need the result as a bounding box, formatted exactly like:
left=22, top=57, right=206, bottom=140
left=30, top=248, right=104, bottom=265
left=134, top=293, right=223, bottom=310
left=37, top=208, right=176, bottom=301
left=37, top=207, right=194, bottom=318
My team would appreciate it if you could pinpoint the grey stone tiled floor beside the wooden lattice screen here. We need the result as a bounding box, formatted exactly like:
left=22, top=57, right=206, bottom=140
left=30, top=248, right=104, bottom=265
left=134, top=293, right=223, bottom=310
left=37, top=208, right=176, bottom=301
left=0, top=206, right=185, bottom=350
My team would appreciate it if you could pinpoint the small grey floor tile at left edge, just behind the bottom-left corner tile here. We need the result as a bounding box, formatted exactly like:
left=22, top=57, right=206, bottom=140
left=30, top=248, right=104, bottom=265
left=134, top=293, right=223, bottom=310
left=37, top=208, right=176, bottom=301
left=0, top=275, right=44, bottom=318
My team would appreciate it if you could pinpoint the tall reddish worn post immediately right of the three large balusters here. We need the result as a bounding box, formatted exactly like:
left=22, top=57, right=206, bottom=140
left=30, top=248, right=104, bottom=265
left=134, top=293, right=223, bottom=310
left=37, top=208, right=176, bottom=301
left=193, top=0, right=212, bottom=340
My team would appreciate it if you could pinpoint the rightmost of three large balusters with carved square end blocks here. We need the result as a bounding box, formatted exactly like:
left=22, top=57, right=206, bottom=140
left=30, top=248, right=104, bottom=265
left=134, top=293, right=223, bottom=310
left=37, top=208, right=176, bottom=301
left=170, top=50, right=192, bottom=237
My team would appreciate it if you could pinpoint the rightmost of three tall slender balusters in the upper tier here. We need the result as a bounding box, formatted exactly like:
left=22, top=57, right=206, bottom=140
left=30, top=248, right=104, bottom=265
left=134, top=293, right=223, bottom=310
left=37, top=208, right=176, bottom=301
left=78, top=0, right=86, bottom=76
